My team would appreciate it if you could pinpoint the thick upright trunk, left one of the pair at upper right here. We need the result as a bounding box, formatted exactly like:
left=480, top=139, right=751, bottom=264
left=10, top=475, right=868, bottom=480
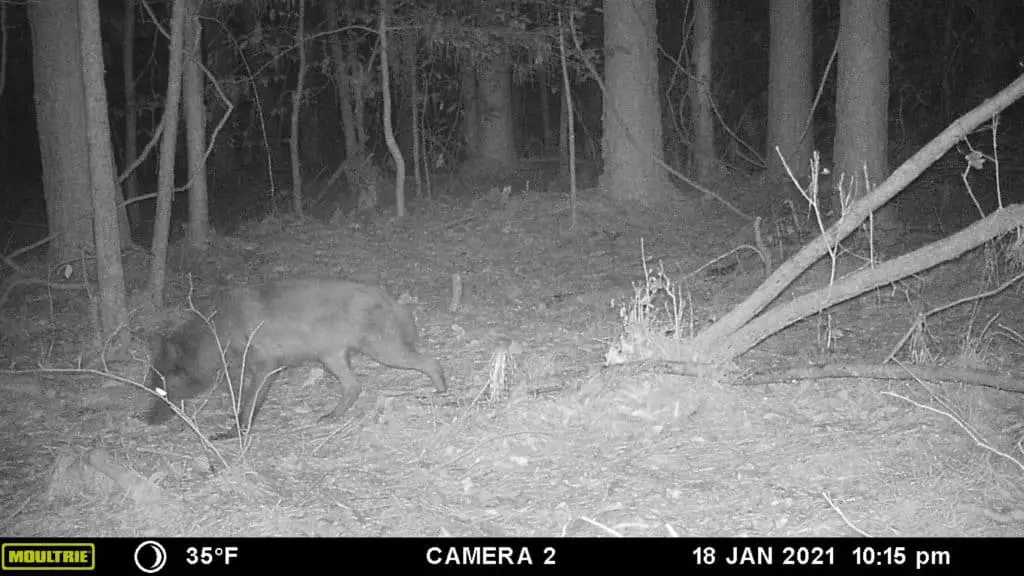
left=767, top=0, right=814, bottom=179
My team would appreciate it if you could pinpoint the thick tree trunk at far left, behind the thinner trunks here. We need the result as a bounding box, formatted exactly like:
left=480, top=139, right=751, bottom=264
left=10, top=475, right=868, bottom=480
left=28, top=2, right=94, bottom=262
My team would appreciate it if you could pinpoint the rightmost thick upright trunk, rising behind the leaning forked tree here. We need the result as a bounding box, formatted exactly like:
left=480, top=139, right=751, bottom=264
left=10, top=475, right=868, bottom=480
left=830, top=0, right=897, bottom=232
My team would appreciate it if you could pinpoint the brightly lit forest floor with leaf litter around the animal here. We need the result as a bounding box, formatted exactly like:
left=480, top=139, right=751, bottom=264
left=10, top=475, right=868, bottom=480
left=0, top=166, right=1024, bottom=536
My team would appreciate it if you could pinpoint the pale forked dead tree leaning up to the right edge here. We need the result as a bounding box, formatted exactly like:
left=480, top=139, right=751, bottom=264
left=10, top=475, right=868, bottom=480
left=690, top=76, right=1024, bottom=364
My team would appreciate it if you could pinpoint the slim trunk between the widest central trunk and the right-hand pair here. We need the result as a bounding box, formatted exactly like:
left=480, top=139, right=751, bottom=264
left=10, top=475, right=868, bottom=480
left=690, top=0, right=718, bottom=183
